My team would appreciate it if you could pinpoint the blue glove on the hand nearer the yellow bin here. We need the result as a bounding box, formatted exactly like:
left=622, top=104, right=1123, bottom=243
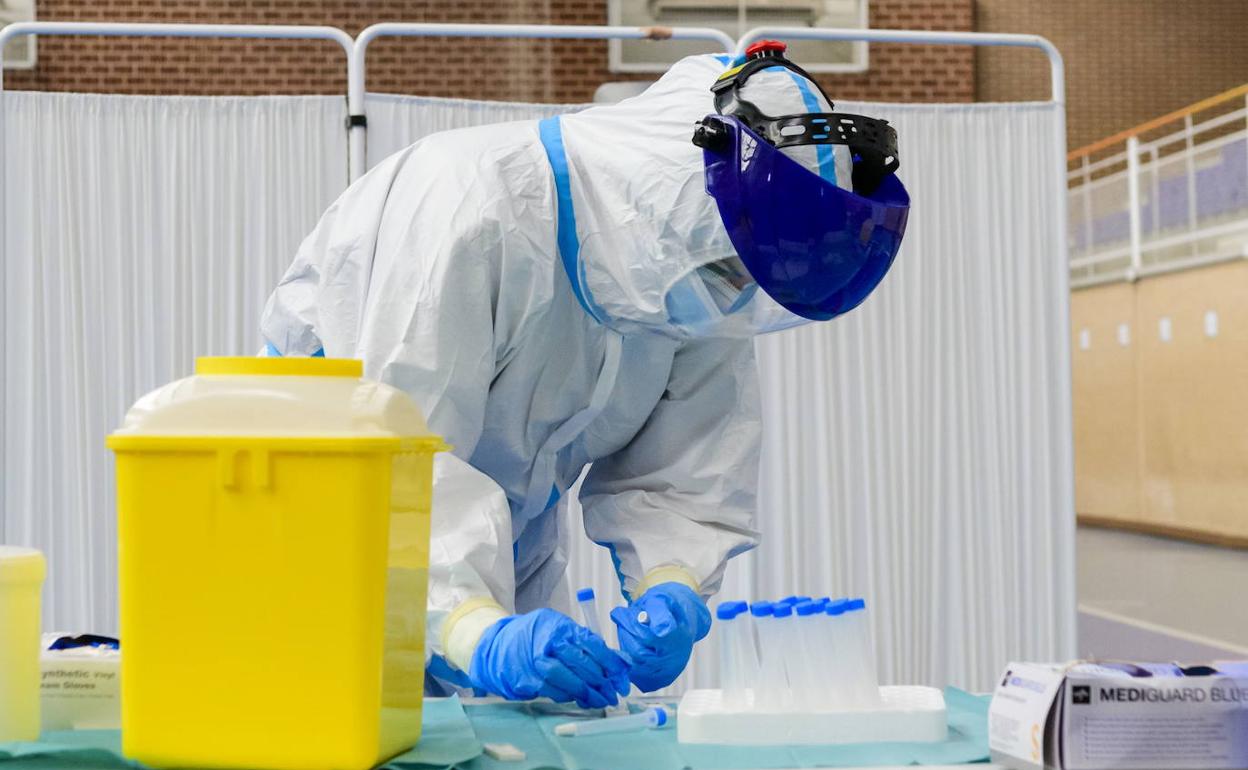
left=468, top=609, right=628, bottom=709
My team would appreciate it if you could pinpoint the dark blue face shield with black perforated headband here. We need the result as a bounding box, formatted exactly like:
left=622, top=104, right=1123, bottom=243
left=690, top=42, right=910, bottom=324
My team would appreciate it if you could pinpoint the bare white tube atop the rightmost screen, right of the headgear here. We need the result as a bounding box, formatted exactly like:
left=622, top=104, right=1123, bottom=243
left=736, top=26, right=1066, bottom=104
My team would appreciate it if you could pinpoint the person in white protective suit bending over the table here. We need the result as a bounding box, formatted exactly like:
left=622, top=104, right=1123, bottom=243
left=262, top=44, right=909, bottom=706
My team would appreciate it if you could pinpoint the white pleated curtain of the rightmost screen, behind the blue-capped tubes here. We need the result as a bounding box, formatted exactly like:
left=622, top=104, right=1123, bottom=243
left=569, top=104, right=1076, bottom=690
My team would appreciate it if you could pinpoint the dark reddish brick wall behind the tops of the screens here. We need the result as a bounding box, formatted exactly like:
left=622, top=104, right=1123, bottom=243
left=5, top=0, right=975, bottom=102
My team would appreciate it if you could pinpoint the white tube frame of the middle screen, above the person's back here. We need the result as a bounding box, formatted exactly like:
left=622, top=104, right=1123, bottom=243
left=347, top=22, right=736, bottom=181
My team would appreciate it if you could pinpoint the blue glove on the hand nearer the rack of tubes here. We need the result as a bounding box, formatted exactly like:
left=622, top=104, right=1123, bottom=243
left=612, top=583, right=710, bottom=693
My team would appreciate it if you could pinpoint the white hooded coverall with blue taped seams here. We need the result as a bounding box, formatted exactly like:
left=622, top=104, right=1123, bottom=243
left=261, top=56, right=850, bottom=671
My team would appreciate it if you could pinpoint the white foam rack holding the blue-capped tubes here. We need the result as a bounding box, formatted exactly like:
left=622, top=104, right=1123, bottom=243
left=676, top=686, right=947, bottom=746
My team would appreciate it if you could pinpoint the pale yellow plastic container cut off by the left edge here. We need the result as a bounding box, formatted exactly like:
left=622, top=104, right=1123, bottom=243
left=0, top=545, right=47, bottom=743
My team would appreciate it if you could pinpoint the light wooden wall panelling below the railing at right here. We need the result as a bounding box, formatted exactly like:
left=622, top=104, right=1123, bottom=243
left=1071, top=262, right=1248, bottom=543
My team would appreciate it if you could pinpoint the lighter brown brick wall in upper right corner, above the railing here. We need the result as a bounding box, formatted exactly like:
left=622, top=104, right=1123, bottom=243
left=975, top=0, right=1248, bottom=149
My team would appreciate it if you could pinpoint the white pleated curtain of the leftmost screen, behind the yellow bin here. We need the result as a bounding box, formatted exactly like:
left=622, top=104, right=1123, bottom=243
left=0, top=92, right=347, bottom=631
